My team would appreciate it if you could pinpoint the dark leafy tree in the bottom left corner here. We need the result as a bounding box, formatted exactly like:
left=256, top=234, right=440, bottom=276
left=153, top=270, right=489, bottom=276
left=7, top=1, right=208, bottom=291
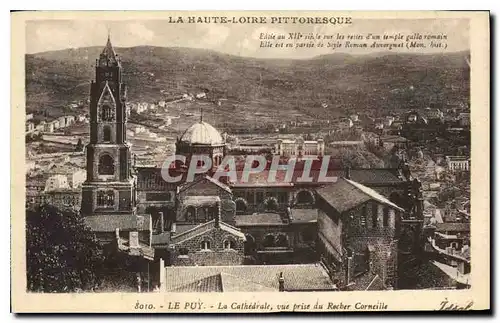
left=26, top=205, right=104, bottom=292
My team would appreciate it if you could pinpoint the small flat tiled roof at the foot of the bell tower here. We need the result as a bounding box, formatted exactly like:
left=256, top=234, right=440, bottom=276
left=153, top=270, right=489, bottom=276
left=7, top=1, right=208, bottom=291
left=84, top=214, right=151, bottom=232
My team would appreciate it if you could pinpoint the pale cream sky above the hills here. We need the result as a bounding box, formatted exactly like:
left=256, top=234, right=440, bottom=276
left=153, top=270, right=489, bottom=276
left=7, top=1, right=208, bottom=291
left=26, top=15, right=470, bottom=58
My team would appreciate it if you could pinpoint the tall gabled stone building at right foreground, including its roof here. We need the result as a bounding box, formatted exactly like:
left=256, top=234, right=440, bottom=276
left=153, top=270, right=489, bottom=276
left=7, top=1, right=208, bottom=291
left=316, top=177, right=404, bottom=290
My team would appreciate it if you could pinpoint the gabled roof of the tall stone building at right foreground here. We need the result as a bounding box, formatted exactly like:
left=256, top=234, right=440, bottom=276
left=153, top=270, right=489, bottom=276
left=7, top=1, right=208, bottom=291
left=316, top=178, right=402, bottom=213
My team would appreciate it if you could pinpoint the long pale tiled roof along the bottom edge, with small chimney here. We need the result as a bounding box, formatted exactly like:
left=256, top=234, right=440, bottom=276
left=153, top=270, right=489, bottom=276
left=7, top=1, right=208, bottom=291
left=165, top=264, right=334, bottom=292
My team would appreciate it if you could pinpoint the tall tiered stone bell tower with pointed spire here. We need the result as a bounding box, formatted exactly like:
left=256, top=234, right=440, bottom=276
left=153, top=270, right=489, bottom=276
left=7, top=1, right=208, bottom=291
left=81, top=36, right=136, bottom=216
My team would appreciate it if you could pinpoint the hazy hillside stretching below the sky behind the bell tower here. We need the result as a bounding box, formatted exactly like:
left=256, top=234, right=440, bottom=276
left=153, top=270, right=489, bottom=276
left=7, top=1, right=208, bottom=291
left=26, top=46, right=469, bottom=118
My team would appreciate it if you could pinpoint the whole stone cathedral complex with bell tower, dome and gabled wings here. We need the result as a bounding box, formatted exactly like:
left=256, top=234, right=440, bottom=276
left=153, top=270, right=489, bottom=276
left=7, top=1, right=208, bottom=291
left=81, top=37, right=422, bottom=288
